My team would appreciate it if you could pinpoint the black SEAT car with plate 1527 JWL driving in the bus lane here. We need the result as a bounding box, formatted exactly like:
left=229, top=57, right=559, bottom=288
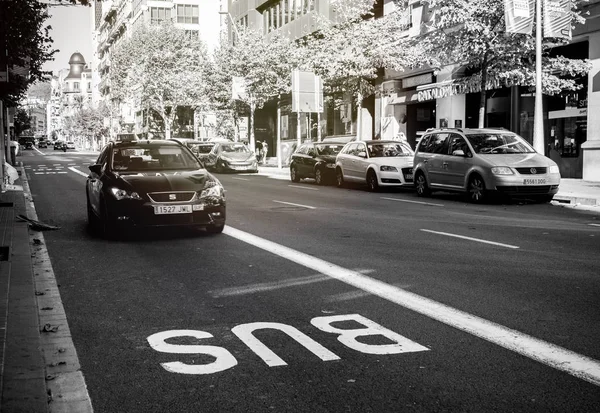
left=86, top=140, right=225, bottom=237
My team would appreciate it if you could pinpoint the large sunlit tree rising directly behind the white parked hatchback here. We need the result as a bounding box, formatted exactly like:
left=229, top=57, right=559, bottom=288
left=300, top=0, right=422, bottom=138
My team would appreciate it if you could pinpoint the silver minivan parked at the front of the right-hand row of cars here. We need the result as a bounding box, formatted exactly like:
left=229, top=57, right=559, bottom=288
left=413, top=128, right=560, bottom=202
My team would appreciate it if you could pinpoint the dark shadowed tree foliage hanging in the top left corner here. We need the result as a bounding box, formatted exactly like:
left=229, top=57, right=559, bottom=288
left=0, top=0, right=56, bottom=106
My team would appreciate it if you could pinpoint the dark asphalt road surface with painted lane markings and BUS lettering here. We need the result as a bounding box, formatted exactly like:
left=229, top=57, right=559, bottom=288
left=20, top=150, right=600, bottom=413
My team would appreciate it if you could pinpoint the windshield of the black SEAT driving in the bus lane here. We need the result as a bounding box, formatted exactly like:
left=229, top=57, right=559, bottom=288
left=112, top=144, right=202, bottom=172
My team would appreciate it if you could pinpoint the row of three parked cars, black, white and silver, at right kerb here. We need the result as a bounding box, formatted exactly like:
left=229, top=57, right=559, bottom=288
left=290, top=128, right=560, bottom=202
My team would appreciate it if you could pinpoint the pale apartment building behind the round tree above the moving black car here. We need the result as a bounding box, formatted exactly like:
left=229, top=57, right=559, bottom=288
left=91, top=0, right=220, bottom=136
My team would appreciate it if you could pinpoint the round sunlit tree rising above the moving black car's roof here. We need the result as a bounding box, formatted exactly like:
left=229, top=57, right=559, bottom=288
left=110, top=22, right=209, bottom=138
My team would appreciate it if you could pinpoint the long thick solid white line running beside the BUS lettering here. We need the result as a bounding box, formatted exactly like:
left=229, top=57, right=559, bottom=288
left=223, top=226, right=600, bottom=386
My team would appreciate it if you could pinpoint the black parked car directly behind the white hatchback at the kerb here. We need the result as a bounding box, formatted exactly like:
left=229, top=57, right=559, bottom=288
left=290, top=142, right=344, bottom=185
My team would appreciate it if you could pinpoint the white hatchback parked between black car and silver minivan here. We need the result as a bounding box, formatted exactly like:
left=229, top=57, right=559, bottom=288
left=335, top=140, right=414, bottom=191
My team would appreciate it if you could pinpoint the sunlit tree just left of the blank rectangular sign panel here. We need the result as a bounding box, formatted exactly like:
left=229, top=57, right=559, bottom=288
left=210, top=26, right=298, bottom=148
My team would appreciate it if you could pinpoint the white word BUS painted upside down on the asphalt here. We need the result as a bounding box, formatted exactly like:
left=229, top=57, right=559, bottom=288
left=147, top=314, right=429, bottom=374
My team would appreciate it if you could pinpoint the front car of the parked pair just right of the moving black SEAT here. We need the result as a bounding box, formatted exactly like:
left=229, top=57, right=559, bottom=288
left=205, top=141, right=258, bottom=172
